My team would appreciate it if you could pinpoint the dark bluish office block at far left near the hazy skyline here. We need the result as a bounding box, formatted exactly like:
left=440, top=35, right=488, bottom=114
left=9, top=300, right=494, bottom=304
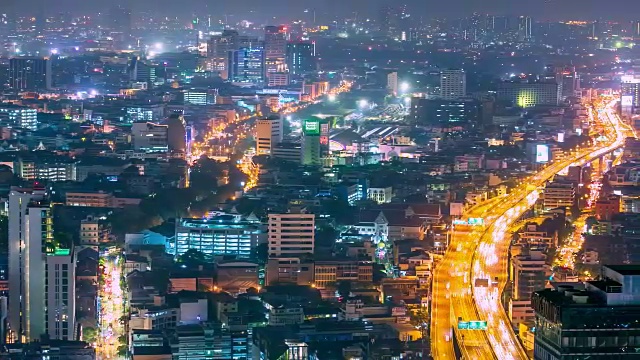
left=9, top=57, right=51, bottom=91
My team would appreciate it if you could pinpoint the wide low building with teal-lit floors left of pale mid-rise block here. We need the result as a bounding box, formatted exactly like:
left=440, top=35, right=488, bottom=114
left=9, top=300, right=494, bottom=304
left=175, top=214, right=263, bottom=258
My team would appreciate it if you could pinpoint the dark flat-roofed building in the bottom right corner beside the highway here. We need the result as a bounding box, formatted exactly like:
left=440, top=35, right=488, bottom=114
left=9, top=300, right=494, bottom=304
left=532, top=265, right=640, bottom=360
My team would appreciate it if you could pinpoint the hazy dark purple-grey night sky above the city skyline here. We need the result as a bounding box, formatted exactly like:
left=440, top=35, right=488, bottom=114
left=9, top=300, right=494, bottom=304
left=6, top=0, right=640, bottom=20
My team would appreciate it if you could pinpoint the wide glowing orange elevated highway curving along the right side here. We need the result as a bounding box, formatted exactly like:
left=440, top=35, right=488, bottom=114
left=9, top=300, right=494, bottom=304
left=431, top=96, right=632, bottom=360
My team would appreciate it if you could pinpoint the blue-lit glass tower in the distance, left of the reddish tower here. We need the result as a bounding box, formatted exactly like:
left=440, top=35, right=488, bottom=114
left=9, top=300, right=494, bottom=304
left=228, top=42, right=265, bottom=85
